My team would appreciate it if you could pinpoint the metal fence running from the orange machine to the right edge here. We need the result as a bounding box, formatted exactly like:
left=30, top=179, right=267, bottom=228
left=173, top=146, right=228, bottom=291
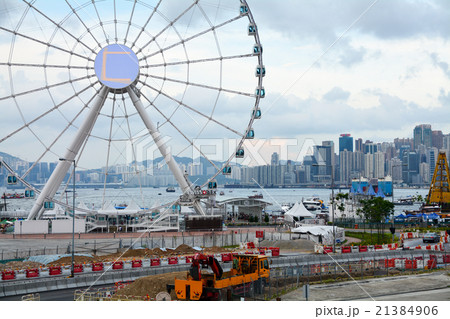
left=233, top=251, right=450, bottom=300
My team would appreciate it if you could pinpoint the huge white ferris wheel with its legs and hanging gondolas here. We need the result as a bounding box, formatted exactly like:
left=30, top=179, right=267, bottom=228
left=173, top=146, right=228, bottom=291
left=0, top=0, right=265, bottom=219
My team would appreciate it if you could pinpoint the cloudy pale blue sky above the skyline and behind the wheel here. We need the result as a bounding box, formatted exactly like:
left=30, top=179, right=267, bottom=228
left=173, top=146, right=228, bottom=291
left=0, top=0, right=450, bottom=170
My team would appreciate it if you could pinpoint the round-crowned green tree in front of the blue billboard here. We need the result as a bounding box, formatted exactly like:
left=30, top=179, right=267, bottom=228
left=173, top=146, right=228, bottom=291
left=358, top=197, right=394, bottom=244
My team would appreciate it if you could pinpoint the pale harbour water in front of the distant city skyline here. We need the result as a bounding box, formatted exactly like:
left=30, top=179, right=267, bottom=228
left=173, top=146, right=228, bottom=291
left=0, top=187, right=428, bottom=215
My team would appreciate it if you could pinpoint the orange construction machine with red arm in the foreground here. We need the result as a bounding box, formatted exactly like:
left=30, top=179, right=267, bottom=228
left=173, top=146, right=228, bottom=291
left=167, top=253, right=270, bottom=300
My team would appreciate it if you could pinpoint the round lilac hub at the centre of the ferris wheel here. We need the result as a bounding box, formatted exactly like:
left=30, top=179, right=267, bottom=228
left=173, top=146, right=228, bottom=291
left=94, top=44, right=139, bottom=90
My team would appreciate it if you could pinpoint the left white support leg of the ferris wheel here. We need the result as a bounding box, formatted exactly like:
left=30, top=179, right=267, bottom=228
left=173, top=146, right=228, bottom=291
left=27, top=87, right=109, bottom=220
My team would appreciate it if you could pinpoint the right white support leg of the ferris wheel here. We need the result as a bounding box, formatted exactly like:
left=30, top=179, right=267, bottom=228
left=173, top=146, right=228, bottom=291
left=127, top=87, right=206, bottom=215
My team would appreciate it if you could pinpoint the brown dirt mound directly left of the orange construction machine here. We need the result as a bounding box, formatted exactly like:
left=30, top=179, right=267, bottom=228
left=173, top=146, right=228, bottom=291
left=116, top=271, right=187, bottom=300
